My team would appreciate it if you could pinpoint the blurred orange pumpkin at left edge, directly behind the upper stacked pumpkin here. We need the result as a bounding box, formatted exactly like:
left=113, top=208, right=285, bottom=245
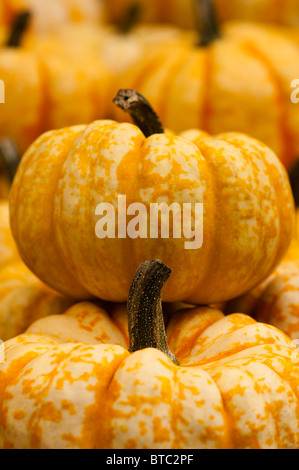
left=0, top=11, right=110, bottom=154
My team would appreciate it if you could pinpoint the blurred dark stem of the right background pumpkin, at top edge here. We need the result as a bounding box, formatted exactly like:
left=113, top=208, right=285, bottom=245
left=195, top=0, right=221, bottom=47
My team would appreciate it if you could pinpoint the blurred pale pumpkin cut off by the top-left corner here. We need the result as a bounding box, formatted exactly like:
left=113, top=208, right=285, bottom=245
left=0, top=0, right=104, bottom=33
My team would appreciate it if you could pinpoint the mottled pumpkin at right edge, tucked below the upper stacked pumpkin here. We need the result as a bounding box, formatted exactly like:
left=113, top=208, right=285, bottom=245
left=223, top=240, right=299, bottom=339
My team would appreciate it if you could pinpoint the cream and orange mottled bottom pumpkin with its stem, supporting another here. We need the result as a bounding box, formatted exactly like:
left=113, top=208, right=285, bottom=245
left=0, top=260, right=299, bottom=449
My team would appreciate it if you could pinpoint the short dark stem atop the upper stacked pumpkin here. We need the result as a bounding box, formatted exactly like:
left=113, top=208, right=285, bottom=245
left=113, top=90, right=164, bottom=137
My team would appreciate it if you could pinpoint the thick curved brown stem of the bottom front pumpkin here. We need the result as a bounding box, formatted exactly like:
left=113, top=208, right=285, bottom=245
left=128, top=260, right=179, bottom=365
